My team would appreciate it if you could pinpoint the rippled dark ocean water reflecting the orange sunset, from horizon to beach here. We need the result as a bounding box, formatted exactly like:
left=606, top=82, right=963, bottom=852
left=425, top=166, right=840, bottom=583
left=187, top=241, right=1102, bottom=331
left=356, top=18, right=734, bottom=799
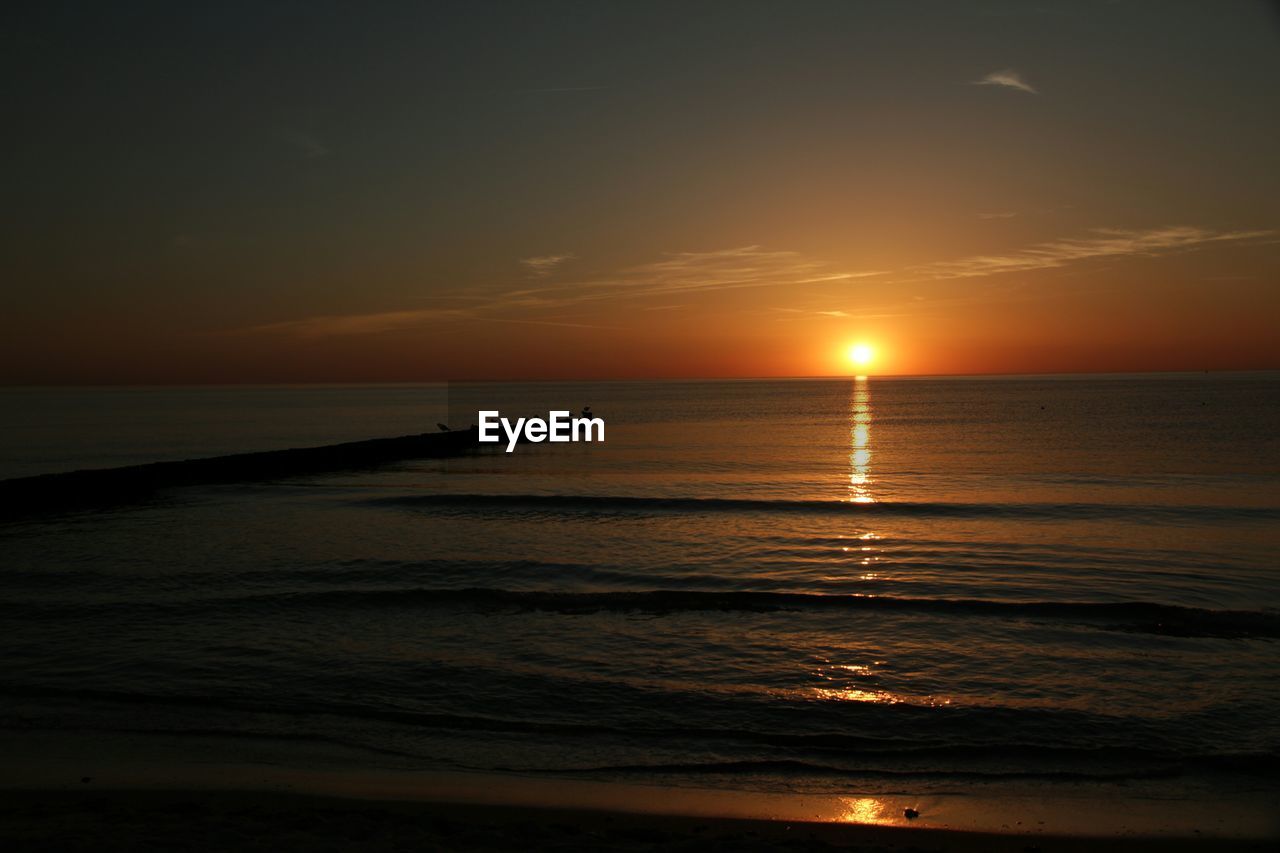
left=0, top=374, right=1280, bottom=797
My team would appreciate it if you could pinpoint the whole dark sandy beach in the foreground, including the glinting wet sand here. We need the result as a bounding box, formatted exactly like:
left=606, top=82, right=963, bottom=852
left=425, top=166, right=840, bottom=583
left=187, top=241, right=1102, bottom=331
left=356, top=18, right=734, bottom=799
left=0, top=730, right=1276, bottom=853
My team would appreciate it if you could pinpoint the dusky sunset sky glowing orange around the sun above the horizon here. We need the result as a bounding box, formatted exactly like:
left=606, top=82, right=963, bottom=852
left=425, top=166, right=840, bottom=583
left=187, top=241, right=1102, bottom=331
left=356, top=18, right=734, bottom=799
left=0, top=0, right=1280, bottom=384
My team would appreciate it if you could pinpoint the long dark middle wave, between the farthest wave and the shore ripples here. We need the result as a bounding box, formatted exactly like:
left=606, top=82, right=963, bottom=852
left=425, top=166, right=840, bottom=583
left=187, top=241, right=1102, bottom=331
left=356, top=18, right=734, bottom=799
left=201, top=587, right=1280, bottom=639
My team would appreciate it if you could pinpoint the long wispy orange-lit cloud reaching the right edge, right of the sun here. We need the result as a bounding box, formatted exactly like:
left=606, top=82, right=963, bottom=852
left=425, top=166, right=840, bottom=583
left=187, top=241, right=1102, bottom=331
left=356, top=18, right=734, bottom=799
left=905, top=225, right=1277, bottom=280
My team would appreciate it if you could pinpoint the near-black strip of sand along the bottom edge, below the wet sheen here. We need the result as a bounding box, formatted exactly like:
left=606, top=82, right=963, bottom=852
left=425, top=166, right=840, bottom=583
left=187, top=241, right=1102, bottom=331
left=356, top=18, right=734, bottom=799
left=0, top=789, right=1271, bottom=853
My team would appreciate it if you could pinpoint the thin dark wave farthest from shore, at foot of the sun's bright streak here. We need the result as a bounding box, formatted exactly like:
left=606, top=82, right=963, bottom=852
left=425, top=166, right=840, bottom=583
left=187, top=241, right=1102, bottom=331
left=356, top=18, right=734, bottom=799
left=362, top=494, right=1280, bottom=521
